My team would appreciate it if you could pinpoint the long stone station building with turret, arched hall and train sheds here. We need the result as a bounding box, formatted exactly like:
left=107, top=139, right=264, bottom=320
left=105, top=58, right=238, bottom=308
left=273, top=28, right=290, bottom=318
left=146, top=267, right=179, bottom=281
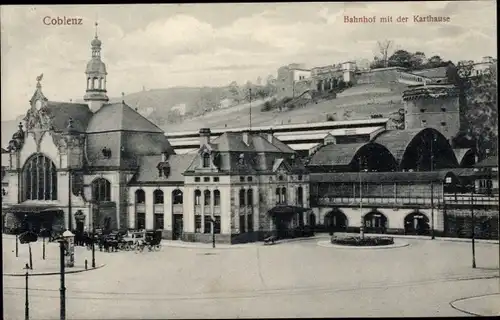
left=2, top=35, right=498, bottom=243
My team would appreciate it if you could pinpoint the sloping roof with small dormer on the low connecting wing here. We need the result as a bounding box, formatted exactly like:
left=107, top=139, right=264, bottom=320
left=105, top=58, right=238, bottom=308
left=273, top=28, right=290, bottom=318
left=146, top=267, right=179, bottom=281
left=129, top=154, right=196, bottom=185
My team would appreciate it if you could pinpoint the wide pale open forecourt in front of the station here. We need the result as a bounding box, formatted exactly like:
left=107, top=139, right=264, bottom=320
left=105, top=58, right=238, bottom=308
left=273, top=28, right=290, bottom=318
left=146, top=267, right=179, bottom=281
left=3, top=237, right=499, bottom=319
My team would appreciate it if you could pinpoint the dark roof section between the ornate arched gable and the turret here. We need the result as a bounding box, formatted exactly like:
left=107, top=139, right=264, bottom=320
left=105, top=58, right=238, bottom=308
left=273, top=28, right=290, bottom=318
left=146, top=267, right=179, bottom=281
left=46, top=101, right=92, bottom=132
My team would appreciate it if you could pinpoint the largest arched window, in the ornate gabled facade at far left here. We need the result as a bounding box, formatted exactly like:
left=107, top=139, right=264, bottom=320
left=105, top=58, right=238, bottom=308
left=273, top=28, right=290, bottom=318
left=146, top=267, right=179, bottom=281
left=23, top=154, right=57, bottom=200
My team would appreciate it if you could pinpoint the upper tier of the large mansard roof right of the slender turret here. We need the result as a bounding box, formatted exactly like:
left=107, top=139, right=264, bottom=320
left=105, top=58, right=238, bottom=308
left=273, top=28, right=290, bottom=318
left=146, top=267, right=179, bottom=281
left=87, top=102, right=163, bottom=133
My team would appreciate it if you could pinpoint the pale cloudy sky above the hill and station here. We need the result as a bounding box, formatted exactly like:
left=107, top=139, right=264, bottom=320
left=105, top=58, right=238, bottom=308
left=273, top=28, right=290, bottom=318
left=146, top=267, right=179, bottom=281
left=0, top=0, right=497, bottom=121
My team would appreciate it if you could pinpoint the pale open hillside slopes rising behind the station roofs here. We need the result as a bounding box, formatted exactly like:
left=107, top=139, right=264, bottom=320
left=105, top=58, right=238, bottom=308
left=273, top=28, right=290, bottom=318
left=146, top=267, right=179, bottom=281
left=1, top=83, right=406, bottom=147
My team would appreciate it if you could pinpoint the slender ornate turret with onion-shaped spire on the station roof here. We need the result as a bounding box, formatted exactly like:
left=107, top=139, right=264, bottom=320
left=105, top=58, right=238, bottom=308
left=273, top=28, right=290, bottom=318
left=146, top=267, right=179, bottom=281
left=83, top=22, right=109, bottom=112
